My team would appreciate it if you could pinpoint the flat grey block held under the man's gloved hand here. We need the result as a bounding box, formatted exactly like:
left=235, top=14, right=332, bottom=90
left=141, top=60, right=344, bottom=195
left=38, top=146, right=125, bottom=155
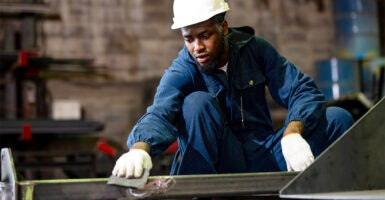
left=107, top=169, right=150, bottom=189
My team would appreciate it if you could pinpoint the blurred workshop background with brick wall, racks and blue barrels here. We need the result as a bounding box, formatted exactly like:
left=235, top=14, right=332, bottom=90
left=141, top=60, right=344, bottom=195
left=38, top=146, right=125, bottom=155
left=0, top=0, right=385, bottom=179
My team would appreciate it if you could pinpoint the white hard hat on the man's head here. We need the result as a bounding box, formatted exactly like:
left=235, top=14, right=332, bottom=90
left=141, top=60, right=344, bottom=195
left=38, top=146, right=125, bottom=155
left=171, top=0, right=230, bottom=29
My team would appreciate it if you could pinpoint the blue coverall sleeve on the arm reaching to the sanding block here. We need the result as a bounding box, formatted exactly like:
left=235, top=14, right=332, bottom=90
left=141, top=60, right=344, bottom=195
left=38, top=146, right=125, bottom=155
left=127, top=57, right=196, bottom=156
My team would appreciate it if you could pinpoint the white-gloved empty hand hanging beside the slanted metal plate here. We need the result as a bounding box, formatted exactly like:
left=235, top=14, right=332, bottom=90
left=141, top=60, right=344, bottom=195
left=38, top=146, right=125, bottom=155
left=281, top=133, right=314, bottom=171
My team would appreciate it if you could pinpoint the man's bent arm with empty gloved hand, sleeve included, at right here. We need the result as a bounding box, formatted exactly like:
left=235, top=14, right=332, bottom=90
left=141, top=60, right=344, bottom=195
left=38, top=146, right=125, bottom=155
left=254, top=40, right=316, bottom=171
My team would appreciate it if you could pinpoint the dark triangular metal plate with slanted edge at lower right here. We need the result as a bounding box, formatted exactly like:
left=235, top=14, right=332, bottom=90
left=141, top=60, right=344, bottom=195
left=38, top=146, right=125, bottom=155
left=280, top=98, right=385, bottom=199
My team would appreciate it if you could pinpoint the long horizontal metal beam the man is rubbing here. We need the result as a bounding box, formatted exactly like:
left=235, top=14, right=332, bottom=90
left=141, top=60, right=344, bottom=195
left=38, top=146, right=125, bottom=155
left=18, top=172, right=297, bottom=200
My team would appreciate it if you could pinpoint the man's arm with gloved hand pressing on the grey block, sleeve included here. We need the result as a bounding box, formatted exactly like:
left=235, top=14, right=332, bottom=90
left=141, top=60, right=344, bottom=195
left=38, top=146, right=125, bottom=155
left=112, top=49, right=200, bottom=178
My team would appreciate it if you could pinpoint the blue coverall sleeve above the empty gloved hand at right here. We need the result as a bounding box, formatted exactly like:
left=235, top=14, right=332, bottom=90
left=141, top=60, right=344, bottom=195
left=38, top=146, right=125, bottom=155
left=257, top=39, right=325, bottom=130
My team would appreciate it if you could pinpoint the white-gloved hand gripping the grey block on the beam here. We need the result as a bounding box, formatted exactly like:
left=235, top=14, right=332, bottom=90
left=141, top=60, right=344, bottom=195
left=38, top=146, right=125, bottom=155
left=112, top=149, right=152, bottom=178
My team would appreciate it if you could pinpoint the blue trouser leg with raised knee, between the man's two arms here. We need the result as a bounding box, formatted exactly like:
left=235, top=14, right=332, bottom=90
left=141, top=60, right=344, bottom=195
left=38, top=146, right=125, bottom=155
left=171, top=92, right=245, bottom=174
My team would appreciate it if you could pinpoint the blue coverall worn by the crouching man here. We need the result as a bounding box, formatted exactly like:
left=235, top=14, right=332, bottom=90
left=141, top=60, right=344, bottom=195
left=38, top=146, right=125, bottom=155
left=127, top=27, right=353, bottom=174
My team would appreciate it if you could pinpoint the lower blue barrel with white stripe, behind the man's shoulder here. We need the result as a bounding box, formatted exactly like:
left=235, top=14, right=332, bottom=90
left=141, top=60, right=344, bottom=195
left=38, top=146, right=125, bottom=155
left=315, top=58, right=360, bottom=100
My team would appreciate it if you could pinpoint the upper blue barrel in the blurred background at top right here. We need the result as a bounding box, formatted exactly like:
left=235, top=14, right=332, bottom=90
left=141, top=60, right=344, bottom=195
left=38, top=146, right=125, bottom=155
left=332, top=0, right=380, bottom=59
